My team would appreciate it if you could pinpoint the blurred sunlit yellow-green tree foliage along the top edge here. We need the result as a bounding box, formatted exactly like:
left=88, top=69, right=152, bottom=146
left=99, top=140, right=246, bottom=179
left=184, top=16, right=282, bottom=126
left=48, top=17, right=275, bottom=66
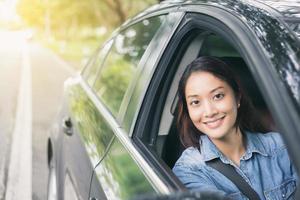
left=17, top=0, right=157, bottom=36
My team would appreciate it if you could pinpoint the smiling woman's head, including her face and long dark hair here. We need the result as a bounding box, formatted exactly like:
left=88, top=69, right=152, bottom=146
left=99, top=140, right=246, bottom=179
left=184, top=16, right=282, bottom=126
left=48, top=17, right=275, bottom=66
left=178, top=57, right=266, bottom=146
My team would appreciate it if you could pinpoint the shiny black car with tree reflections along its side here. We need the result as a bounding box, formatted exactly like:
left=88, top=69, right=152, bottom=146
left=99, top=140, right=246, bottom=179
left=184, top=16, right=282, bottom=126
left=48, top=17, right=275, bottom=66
left=48, top=0, right=300, bottom=200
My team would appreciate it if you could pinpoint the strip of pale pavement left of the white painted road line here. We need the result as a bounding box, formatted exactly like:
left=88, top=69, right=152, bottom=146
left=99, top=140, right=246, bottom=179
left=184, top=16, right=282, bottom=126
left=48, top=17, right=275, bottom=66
left=0, top=32, right=21, bottom=199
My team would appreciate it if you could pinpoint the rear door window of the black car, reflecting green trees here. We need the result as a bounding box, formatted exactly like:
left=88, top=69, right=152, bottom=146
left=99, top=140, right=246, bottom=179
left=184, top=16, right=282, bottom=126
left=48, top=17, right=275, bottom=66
left=94, top=16, right=165, bottom=116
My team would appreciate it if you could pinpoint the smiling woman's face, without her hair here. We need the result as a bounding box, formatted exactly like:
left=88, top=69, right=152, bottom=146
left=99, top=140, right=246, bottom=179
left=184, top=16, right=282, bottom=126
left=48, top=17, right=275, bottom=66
left=185, top=72, right=238, bottom=139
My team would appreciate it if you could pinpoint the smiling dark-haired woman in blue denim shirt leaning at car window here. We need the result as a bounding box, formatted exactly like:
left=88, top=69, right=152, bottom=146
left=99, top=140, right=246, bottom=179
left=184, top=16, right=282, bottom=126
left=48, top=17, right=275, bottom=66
left=173, top=56, right=297, bottom=199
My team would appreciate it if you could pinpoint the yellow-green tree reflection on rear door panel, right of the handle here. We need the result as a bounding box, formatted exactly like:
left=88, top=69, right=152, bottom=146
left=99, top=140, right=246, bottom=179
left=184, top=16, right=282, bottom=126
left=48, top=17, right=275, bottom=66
left=69, top=85, right=113, bottom=166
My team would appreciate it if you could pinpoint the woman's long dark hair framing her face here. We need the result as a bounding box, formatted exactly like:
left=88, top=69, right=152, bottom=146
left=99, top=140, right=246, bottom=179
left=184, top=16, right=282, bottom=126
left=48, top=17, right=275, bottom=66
left=177, top=56, right=267, bottom=147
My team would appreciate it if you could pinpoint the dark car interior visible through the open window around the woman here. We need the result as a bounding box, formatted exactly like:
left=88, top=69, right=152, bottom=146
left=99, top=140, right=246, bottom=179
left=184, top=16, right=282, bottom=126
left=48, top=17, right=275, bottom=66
left=155, top=32, right=276, bottom=168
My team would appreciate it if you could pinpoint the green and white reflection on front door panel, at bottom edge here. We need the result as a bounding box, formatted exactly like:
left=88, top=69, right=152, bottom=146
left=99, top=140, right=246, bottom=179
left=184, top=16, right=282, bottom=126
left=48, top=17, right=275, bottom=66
left=91, top=138, right=155, bottom=200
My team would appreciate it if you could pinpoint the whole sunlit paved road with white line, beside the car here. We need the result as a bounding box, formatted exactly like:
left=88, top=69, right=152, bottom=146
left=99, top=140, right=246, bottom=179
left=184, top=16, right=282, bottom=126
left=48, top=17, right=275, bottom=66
left=0, top=31, right=74, bottom=200
